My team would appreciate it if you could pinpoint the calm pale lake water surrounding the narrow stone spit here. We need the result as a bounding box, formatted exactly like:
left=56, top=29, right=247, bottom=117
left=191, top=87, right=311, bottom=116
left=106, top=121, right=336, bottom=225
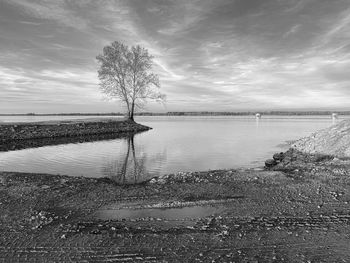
left=0, top=116, right=339, bottom=183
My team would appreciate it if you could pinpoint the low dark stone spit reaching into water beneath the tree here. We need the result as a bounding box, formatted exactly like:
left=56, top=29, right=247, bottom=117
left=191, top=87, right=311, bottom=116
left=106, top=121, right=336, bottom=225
left=0, top=119, right=151, bottom=144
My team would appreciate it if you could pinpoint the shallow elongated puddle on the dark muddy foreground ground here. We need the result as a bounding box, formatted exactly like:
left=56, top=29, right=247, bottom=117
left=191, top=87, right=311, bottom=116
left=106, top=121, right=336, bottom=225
left=95, top=206, right=225, bottom=221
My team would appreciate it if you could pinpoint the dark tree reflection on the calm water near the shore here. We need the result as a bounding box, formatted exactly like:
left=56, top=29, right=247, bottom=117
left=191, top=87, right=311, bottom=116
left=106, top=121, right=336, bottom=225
left=102, top=134, right=166, bottom=184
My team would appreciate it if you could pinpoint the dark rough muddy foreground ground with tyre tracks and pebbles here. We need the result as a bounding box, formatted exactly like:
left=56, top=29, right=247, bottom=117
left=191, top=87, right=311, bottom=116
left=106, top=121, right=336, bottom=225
left=0, top=151, right=350, bottom=262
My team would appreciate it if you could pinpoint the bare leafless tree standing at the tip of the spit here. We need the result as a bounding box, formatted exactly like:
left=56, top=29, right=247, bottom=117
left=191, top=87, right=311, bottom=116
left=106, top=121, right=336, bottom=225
left=96, top=41, right=165, bottom=120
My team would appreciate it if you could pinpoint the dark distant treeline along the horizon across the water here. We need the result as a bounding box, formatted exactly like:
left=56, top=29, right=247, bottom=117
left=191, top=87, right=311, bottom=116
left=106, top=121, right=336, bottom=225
left=0, top=111, right=350, bottom=116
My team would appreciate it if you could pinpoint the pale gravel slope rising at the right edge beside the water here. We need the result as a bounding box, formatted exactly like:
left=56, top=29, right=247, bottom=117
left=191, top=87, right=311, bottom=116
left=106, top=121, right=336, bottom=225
left=292, top=120, right=350, bottom=157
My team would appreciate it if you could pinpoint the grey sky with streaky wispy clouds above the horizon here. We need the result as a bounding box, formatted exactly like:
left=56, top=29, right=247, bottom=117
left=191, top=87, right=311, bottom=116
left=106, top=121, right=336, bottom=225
left=0, top=0, right=350, bottom=113
